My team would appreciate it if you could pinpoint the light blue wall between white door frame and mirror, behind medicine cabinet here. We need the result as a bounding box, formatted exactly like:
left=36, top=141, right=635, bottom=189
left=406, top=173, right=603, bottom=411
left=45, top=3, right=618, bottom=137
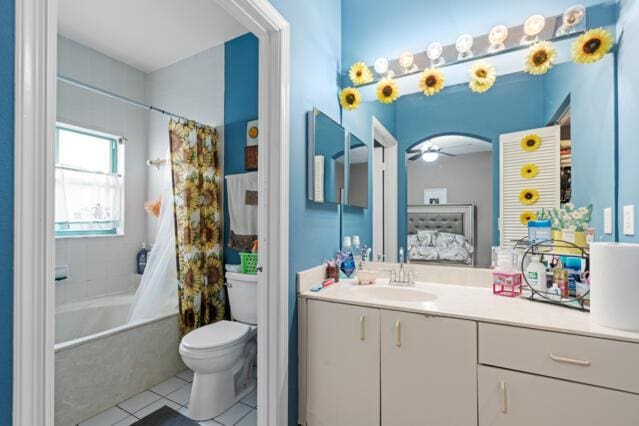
left=271, top=0, right=342, bottom=425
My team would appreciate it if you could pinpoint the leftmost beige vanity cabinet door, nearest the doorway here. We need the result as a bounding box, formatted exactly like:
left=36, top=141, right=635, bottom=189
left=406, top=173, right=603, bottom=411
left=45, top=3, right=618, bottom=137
left=306, top=300, right=379, bottom=426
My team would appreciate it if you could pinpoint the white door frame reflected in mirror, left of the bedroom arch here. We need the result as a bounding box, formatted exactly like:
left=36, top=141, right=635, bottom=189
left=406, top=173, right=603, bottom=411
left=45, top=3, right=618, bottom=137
left=372, top=117, right=399, bottom=262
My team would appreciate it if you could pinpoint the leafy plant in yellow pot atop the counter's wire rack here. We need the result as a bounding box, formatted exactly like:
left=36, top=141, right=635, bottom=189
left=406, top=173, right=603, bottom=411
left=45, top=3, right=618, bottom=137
left=537, top=203, right=594, bottom=254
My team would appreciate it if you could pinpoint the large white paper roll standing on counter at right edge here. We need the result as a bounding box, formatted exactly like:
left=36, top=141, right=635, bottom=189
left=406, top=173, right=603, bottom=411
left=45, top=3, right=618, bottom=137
left=590, top=243, right=639, bottom=330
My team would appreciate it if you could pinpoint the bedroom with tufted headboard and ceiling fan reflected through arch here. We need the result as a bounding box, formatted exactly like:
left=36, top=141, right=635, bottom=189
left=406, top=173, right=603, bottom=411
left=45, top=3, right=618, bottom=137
left=406, top=135, right=493, bottom=267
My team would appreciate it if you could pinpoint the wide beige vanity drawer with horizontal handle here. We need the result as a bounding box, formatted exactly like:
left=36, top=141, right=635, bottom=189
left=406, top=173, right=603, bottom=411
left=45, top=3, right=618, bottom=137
left=478, top=323, right=639, bottom=393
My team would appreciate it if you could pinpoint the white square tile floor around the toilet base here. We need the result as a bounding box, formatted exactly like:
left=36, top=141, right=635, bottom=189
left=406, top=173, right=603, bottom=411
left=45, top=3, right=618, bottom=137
left=79, top=370, right=257, bottom=426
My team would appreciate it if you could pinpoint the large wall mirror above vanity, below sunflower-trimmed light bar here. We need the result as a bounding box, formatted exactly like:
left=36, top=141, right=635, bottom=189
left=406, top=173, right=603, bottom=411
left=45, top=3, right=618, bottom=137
left=342, top=33, right=617, bottom=267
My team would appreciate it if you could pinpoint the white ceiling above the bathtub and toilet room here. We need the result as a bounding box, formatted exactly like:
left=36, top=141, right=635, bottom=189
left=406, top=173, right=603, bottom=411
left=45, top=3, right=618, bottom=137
left=58, top=0, right=247, bottom=73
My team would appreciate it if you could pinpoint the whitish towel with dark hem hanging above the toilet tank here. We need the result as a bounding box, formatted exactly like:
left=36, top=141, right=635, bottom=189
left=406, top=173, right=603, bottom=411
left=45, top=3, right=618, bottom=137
left=226, top=172, right=258, bottom=249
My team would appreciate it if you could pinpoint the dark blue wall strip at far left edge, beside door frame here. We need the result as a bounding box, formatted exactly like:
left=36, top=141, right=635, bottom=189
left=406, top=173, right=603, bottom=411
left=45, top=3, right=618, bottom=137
left=0, top=0, right=15, bottom=425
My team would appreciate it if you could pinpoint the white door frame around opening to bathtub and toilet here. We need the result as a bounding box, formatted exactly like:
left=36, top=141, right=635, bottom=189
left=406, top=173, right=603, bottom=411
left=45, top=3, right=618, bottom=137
left=13, top=0, right=290, bottom=426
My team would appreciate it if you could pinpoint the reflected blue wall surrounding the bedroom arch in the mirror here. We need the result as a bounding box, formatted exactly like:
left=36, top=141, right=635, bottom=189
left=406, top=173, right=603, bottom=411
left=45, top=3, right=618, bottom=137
left=396, top=74, right=544, bottom=246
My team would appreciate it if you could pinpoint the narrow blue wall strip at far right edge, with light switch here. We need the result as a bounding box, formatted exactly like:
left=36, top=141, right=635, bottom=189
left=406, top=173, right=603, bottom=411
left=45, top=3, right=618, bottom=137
left=617, top=0, right=639, bottom=243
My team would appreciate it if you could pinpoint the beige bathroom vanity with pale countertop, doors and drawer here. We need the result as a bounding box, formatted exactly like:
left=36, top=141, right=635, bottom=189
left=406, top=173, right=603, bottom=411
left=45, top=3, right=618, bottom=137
left=299, top=268, right=639, bottom=426
